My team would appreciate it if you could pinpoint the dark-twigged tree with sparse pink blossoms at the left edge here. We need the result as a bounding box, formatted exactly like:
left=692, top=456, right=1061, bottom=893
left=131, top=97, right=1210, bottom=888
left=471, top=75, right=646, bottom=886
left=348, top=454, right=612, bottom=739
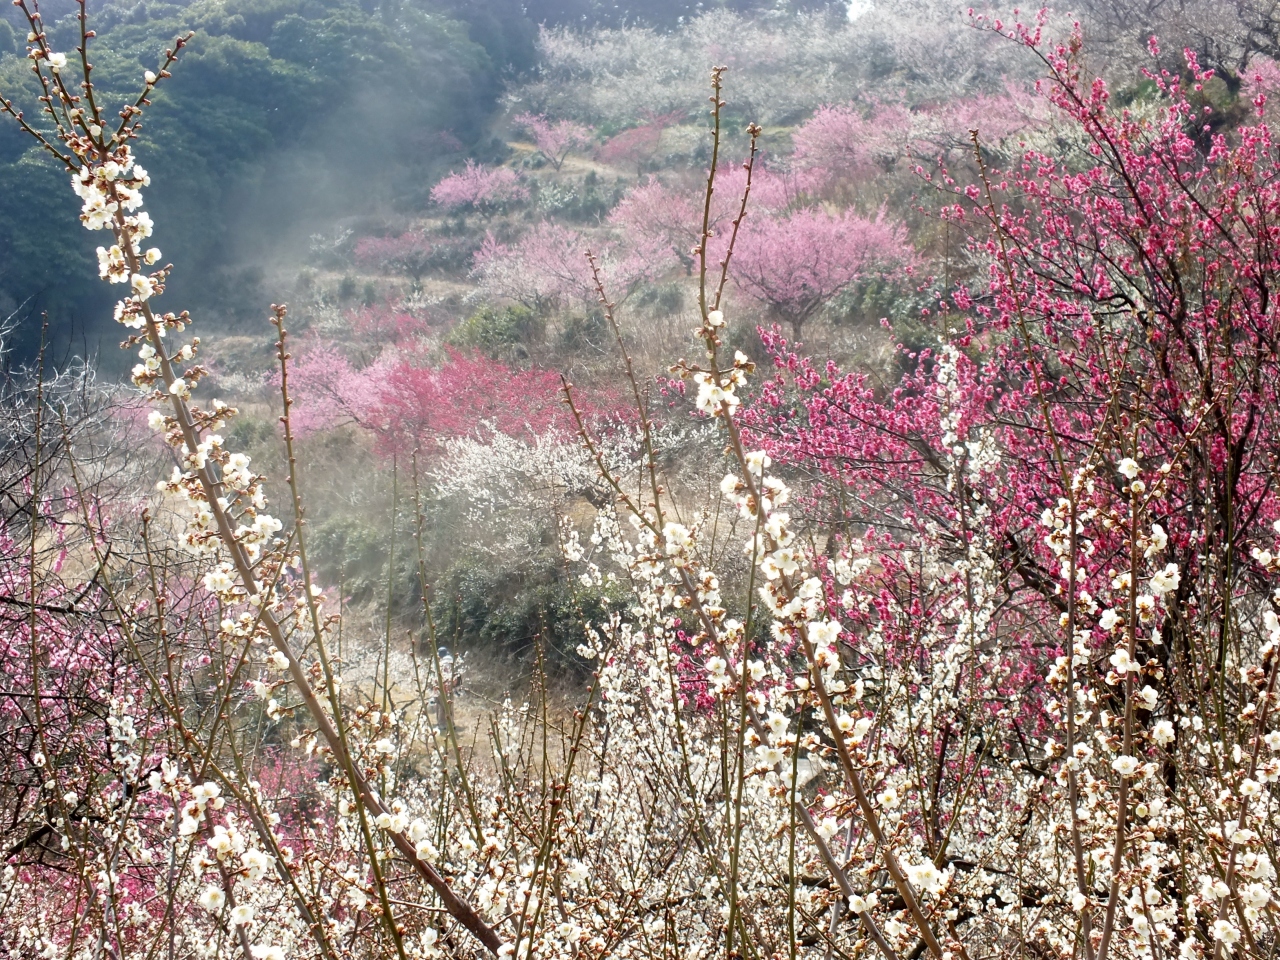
left=0, top=348, right=159, bottom=916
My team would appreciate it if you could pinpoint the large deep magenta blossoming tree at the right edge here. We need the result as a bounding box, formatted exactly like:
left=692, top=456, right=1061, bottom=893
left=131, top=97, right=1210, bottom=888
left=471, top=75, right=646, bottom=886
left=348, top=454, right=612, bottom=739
left=740, top=29, right=1280, bottom=798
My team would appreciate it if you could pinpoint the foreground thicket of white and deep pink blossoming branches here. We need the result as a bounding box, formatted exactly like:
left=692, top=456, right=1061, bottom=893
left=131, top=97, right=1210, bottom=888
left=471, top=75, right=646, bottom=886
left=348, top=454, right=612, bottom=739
left=0, top=3, right=1280, bottom=960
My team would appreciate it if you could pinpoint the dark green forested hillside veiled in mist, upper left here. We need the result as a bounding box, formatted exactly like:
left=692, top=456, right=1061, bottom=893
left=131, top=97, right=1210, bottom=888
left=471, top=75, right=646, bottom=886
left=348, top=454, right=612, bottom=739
left=0, top=0, right=534, bottom=362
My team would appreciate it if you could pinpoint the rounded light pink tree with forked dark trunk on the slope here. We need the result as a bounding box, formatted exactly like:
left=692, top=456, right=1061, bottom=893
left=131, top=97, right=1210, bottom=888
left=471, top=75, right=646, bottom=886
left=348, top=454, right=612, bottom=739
left=733, top=207, right=911, bottom=340
